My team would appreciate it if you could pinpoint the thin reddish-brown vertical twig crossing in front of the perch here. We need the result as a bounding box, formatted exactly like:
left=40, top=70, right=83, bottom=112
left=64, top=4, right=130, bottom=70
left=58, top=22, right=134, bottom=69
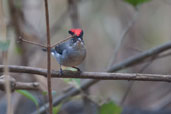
left=44, top=0, right=52, bottom=114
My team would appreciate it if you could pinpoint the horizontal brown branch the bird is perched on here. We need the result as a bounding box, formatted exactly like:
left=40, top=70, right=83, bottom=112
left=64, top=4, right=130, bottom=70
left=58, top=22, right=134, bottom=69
left=0, top=65, right=171, bottom=82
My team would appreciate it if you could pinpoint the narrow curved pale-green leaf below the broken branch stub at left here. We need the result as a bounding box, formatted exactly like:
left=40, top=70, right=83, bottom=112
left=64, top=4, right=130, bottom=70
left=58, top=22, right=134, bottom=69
left=16, top=90, right=39, bottom=107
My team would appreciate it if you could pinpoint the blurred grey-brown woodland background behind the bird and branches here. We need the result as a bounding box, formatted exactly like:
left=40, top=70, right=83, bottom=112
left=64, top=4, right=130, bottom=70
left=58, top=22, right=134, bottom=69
left=0, top=0, right=171, bottom=114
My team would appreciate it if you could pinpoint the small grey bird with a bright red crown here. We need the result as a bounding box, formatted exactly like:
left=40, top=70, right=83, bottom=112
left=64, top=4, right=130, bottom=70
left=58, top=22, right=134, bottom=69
left=51, top=28, right=86, bottom=74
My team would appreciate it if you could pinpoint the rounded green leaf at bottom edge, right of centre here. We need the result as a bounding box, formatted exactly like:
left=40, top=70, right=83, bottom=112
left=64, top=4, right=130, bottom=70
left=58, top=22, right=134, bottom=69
left=100, top=101, right=122, bottom=114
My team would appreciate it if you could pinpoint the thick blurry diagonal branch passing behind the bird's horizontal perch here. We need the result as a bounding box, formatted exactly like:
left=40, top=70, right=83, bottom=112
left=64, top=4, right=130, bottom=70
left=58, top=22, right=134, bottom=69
left=32, top=42, right=171, bottom=114
